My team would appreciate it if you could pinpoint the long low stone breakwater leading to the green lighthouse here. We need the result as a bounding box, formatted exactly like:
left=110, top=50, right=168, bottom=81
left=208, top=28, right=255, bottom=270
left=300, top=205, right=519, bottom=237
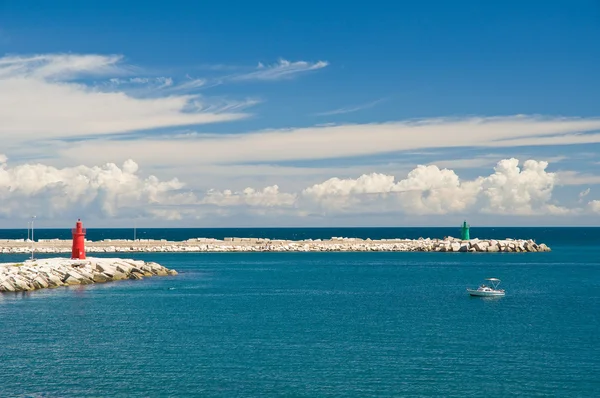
left=0, top=237, right=550, bottom=253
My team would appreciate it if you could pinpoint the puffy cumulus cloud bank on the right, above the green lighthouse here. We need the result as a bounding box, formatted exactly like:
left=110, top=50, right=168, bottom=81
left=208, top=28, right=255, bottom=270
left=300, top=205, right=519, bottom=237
left=200, top=159, right=572, bottom=215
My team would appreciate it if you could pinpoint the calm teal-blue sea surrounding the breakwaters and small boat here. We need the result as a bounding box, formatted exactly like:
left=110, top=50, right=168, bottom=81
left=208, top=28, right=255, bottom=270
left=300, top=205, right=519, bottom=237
left=0, top=228, right=600, bottom=397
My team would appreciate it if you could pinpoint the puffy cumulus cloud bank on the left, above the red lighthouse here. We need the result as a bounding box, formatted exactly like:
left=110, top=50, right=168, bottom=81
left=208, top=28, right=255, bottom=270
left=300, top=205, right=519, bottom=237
left=0, top=159, right=192, bottom=218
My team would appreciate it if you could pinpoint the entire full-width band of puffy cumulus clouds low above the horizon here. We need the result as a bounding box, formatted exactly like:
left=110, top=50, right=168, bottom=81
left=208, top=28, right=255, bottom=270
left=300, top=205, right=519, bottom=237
left=0, top=156, right=600, bottom=221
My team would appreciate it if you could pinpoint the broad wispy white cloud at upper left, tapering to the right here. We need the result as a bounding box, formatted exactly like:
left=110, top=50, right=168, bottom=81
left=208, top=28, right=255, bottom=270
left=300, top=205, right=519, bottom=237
left=0, top=54, right=246, bottom=142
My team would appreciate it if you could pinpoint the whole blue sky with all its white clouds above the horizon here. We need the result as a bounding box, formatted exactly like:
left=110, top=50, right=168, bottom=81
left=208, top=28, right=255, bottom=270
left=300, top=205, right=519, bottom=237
left=0, top=0, right=600, bottom=228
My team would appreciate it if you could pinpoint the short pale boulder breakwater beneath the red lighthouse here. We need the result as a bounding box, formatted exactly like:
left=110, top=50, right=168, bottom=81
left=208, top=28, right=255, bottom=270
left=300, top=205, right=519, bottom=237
left=0, top=258, right=177, bottom=292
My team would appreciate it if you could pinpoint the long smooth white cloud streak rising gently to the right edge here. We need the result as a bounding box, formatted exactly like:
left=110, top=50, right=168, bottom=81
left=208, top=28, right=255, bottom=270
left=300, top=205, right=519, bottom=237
left=55, top=116, right=600, bottom=165
